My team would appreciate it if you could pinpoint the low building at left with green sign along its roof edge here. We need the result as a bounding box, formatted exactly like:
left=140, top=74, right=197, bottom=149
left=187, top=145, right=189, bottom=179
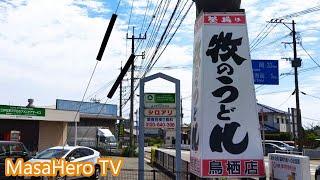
left=0, top=105, right=79, bottom=152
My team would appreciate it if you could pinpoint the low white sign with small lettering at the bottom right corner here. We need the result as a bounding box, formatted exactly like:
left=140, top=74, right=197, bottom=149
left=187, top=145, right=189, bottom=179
left=269, top=153, right=311, bottom=180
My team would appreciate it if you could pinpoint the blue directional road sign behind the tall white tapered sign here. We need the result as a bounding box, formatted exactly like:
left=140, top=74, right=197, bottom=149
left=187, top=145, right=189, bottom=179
left=252, top=60, right=279, bottom=85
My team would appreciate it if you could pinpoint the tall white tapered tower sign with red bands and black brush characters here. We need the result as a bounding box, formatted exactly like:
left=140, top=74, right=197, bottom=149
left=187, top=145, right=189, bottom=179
left=190, top=12, right=265, bottom=178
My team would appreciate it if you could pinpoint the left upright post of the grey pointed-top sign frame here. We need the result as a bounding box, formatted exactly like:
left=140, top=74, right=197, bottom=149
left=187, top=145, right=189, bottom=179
left=138, top=79, right=145, bottom=180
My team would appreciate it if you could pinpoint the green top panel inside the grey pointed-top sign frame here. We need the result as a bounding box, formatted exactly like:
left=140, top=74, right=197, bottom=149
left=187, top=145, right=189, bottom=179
left=144, top=93, right=176, bottom=104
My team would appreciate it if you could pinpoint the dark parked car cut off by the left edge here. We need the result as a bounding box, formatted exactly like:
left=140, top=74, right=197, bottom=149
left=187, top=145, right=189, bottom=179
left=0, top=141, right=31, bottom=179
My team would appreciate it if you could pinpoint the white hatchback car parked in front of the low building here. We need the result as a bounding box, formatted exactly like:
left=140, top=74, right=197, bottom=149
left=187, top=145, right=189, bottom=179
left=28, top=146, right=100, bottom=179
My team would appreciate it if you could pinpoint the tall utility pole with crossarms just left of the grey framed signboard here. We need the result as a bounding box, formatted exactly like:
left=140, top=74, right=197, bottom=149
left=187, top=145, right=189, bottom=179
left=127, top=27, right=146, bottom=156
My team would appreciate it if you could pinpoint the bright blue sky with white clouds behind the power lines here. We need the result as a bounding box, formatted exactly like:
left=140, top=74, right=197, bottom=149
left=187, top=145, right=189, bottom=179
left=0, top=0, right=320, bottom=127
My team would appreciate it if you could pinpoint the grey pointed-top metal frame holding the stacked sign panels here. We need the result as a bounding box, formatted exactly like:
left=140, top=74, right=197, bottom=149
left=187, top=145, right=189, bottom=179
left=138, top=73, right=182, bottom=180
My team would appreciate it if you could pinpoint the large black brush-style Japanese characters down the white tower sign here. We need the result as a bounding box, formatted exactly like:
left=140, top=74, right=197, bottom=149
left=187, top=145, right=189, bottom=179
left=206, top=31, right=249, bottom=154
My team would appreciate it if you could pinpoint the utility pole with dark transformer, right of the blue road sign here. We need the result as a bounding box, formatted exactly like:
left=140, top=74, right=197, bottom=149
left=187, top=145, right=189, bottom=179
left=270, top=19, right=303, bottom=151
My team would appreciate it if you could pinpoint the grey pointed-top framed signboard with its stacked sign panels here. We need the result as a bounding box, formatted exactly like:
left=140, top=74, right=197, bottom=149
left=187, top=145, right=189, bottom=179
left=138, top=73, right=182, bottom=180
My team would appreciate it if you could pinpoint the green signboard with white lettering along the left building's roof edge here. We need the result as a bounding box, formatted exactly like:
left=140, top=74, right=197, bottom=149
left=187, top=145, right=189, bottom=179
left=0, top=105, right=46, bottom=118
